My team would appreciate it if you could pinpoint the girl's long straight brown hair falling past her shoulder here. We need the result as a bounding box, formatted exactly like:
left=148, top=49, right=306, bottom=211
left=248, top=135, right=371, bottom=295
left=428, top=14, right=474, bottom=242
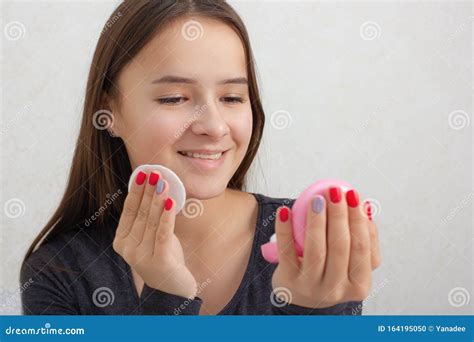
left=22, top=0, right=265, bottom=267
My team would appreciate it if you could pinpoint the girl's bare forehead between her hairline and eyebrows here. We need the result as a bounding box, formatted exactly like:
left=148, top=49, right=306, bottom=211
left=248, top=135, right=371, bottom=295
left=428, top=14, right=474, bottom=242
left=131, top=17, right=246, bottom=81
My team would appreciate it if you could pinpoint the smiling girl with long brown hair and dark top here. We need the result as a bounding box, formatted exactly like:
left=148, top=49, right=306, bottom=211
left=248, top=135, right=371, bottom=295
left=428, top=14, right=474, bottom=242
left=21, top=0, right=380, bottom=315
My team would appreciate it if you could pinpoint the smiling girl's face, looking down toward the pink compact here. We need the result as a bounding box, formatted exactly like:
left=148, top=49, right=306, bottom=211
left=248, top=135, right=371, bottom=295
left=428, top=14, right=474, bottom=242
left=110, top=18, right=252, bottom=199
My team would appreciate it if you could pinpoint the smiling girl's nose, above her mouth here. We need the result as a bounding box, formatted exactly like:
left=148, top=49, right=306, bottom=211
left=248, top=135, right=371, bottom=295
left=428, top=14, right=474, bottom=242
left=191, top=101, right=229, bottom=140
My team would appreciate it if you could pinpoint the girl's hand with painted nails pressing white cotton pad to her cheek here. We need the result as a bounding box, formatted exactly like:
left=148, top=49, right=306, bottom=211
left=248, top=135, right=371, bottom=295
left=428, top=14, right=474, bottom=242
left=113, top=171, right=197, bottom=298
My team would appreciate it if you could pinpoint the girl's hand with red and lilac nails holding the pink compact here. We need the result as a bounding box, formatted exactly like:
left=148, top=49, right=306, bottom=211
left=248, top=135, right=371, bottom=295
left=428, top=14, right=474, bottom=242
left=272, top=187, right=380, bottom=308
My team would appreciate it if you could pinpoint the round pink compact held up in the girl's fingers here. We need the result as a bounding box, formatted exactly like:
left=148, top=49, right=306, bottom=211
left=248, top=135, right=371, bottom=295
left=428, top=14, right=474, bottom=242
left=261, top=178, right=352, bottom=263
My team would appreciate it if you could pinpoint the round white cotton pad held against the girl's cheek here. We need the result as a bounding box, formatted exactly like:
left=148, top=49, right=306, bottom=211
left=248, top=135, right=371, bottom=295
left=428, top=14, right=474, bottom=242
left=128, top=164, right=186, bottom=214
